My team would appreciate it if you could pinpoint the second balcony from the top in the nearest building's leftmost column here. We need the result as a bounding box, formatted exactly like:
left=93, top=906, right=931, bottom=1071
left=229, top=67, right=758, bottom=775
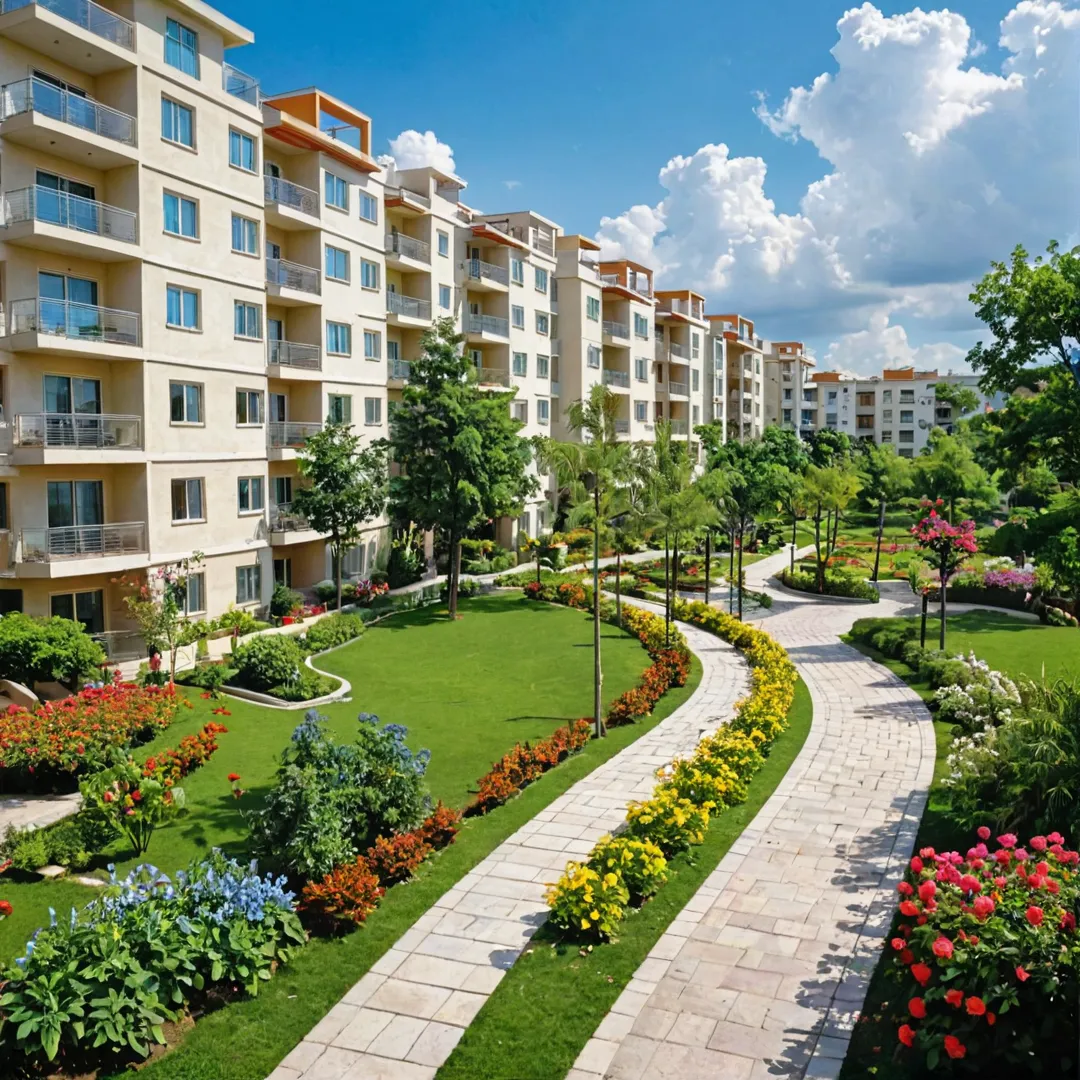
left=0, top=75, right=138, bottom=168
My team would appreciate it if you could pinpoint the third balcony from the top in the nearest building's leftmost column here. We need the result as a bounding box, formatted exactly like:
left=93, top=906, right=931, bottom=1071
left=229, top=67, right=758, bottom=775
left=0, top=186, right=138, bottom=261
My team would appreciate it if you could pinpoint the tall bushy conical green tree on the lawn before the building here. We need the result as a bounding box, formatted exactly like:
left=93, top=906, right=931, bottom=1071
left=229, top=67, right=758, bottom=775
left=390, top=319, right=537, bottom=619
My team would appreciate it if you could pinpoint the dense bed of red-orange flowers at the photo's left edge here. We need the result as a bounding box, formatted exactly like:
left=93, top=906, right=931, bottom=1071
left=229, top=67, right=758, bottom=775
left=0, top=679, right=178, bottom=792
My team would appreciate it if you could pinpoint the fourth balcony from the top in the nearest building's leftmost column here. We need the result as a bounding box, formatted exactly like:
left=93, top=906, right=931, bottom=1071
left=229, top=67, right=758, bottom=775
left=6, top=297, right=141, bottom=360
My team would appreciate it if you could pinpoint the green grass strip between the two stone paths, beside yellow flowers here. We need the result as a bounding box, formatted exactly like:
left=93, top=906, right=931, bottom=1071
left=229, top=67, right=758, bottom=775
left=438, top=679, right=812, bottom=1080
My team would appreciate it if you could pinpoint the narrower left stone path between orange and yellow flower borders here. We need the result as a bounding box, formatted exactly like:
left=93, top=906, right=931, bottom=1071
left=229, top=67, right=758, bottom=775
left=271, top=602, right=750, bottom=1080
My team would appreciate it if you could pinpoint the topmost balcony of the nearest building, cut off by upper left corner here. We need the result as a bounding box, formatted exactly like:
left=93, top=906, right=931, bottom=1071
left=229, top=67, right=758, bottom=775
left=0, top=0, right=135, bottom=76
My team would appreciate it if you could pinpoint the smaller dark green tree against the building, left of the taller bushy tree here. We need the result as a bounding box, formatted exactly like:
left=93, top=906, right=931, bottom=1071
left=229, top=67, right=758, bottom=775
left=293, top=419, right=387, bottom=611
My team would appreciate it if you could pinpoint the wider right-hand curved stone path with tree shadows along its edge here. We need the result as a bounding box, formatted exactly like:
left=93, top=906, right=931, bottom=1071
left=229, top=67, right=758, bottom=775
left=568, top=551, right=935, bottom=1080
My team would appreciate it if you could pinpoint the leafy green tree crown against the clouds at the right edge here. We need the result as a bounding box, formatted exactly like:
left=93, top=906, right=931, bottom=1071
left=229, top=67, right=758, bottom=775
left=968, top=241, right=1080, bottom=392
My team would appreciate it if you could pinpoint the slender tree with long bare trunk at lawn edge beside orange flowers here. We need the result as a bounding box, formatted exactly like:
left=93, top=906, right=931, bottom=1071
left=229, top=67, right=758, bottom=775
left=539, top=382, right=633, bottom=739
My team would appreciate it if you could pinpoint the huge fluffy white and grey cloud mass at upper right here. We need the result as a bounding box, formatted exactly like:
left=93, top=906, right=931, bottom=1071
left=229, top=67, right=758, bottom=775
left=598, top=0, right=1080, bottom=369
